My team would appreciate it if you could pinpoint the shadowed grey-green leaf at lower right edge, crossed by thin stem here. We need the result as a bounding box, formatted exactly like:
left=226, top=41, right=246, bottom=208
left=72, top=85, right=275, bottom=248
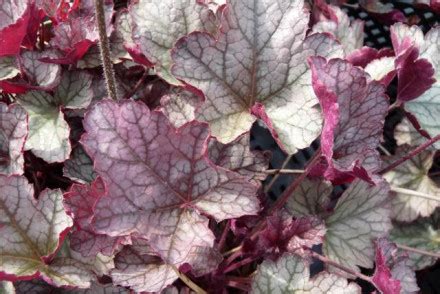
left=390, top=210, right=440, bottom=270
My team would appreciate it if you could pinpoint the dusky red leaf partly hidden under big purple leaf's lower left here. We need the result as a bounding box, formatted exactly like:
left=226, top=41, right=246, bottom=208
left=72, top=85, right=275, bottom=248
left=64, top=178, right=130, bottom=257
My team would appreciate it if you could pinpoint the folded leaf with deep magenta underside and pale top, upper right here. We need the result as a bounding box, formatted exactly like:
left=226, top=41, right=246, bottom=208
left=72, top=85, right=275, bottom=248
left=390, top=24, right=436, bottom=102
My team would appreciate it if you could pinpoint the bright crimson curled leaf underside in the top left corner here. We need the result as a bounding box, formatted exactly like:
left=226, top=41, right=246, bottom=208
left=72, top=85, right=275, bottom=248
left=0, top=0, right=30, bottom=56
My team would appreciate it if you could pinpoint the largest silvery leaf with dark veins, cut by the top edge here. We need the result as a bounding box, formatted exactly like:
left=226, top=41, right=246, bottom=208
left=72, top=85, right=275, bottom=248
left=173, top=0, right=342, bottom=153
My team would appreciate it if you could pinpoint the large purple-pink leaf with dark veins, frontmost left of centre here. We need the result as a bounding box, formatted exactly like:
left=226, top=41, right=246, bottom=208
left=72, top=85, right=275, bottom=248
left=82, top=100, right=259, bottom=272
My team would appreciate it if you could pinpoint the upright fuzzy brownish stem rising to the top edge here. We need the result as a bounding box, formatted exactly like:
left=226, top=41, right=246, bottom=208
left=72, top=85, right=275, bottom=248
left=95, top=0, right=118, bottom=100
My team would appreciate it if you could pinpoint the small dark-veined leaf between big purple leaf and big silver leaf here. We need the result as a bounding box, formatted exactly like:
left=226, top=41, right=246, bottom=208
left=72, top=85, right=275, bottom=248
left=208, top=133, right=269, bottom=185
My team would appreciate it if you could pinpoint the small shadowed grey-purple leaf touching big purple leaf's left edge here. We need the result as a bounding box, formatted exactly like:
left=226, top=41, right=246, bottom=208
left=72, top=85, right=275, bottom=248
left=63, top=145, right=96, bottom=184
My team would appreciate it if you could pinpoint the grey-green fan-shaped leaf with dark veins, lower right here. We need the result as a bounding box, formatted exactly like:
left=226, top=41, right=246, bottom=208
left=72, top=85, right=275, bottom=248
left=323, top=179, right=391, bottom=270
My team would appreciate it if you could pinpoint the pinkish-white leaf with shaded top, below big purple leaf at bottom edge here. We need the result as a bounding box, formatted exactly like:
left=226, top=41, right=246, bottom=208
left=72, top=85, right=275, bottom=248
left=110, top=247, right=178, bottom=293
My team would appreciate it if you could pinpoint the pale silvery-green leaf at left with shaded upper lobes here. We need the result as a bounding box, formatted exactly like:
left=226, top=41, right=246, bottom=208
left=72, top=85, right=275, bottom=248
left=18, top=71, right=93, bottom=162
